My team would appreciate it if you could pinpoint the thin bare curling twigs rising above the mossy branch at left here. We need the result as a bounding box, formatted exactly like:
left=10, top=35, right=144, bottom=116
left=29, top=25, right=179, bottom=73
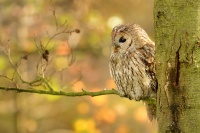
left=0, top=9, right=80, bottom=91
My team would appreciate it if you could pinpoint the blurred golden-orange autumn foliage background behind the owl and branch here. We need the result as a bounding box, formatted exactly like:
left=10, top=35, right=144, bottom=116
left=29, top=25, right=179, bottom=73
left=0, top=0, right=156, bottom=133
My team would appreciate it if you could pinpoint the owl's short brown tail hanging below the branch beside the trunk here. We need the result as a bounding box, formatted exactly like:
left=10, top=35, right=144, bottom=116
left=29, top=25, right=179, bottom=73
left=144, top=101, right=156, bottom=122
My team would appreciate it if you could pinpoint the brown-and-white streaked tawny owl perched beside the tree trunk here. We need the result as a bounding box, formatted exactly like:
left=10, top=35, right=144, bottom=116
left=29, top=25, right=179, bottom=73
left=109, top=24, right=157, bottom=120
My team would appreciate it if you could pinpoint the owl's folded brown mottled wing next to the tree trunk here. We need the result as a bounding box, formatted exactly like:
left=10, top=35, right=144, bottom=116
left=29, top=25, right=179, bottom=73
left=138, top=43, right=157, bottom=92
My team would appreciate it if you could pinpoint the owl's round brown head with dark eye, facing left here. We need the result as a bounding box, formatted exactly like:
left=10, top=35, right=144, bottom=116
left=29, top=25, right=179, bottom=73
left=111, top=24, right=152, bottom=52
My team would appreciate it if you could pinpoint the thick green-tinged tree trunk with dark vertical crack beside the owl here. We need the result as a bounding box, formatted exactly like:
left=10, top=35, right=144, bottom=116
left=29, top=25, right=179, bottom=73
left=154, top=0, right=200, bottom=133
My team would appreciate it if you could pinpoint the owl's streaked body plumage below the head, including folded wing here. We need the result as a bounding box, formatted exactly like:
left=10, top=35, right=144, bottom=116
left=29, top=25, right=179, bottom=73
left=110, top=44, right=157, bottom=100
